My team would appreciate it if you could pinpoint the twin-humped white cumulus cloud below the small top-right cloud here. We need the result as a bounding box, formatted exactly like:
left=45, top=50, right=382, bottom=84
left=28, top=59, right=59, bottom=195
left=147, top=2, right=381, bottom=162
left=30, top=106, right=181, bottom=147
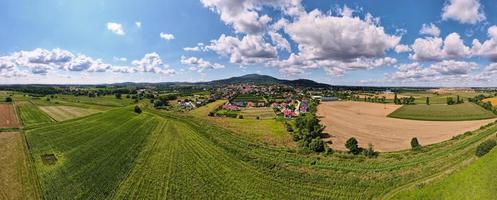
left=409, top=33, right=471, bottom=61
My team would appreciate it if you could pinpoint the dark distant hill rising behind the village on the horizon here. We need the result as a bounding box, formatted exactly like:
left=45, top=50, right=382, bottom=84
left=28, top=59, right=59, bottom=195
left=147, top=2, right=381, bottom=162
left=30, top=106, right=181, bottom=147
left=197, top=74, right=331, bottom=88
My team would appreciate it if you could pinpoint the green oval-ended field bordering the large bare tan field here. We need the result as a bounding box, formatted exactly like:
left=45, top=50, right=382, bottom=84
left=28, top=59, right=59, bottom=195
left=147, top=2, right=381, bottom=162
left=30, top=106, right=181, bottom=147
left=388, top=103, right=496, bottom=121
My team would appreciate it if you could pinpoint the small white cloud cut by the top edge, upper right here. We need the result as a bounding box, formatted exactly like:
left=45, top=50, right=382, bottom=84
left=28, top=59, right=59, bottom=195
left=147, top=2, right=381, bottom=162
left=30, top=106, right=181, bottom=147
left=442, top=0, right=486, bottom=24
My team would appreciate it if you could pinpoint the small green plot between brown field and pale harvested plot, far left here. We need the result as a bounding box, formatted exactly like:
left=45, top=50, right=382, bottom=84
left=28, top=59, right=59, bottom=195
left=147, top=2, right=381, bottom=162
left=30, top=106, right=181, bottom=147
left=16, top=101, right=53, bottom=126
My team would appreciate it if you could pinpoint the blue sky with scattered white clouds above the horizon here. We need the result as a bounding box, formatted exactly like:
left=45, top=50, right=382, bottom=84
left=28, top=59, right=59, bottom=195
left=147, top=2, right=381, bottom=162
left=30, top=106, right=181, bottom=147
left=0, top=0, right=497, bottom=87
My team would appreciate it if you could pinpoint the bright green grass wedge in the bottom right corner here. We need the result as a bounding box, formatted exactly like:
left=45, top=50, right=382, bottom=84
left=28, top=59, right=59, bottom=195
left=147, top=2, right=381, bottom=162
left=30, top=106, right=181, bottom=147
left=395, top=144, right=497, bottom=200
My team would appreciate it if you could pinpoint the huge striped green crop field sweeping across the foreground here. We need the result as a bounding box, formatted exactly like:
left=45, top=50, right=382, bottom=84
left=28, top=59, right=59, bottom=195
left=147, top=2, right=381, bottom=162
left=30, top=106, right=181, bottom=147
left=26, top=103, right=497, bottom=199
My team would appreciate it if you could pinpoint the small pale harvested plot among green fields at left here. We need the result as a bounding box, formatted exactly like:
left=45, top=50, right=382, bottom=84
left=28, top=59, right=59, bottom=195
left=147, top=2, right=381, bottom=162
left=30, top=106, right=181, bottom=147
left=40, top=106, right=98, bottom=121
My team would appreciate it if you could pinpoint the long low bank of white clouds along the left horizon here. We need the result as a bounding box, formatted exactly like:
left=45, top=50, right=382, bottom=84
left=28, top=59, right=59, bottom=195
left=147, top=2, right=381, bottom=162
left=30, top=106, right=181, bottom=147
left=0, top=48, right=174, bottom=76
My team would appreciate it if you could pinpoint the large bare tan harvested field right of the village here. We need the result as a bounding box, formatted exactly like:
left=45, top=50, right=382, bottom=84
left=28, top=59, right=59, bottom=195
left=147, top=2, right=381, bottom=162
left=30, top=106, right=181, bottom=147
left=317, top=101, right=495, bottom=151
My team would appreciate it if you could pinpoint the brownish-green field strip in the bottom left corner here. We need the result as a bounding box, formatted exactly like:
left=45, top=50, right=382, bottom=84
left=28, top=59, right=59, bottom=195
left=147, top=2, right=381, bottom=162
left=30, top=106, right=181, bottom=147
left=0, top=132, right=40, bottom=200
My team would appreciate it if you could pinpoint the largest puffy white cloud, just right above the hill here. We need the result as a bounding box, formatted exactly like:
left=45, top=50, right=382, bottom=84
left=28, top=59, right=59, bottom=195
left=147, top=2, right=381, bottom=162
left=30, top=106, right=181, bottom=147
left=285, top=10, right=400, bottom=61
